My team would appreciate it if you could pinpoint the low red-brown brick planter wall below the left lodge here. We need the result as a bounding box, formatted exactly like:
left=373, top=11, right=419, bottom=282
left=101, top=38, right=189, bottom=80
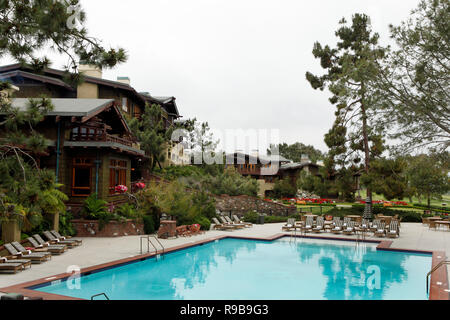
left=72, top=220, right=144, bottom=238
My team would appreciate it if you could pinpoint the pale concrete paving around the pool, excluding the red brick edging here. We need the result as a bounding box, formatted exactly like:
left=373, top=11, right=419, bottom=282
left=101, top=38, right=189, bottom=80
left=0, top=223, right=450, bottom=296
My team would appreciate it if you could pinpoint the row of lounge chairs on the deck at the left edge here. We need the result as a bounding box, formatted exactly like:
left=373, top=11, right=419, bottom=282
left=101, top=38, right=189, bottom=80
left=0, top=230, right=82, bottom=273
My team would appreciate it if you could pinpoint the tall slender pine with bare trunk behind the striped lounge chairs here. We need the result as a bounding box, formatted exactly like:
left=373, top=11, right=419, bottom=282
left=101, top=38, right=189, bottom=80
left=306, top=14, right=385, bottom=213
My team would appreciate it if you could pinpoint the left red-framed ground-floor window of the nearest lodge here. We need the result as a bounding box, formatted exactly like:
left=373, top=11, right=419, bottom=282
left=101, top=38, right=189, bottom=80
left=72, top=158, right=93, bottom=197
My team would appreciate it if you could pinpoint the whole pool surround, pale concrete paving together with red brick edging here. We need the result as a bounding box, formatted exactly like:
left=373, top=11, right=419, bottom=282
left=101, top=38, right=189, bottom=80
left=0, top=223, right=450, bottom=300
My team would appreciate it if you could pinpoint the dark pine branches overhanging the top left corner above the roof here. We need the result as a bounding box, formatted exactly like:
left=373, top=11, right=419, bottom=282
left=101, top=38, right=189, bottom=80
left=0, top=0, right=126, bottom=74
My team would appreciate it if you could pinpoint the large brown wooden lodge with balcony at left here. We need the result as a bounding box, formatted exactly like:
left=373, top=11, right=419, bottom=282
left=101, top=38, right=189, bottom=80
left=0, top=64, right=185, bottom=212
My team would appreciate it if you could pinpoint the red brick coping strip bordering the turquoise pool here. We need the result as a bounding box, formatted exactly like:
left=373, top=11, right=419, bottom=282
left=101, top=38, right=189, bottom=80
left=0, top=233, right=450, bottom=301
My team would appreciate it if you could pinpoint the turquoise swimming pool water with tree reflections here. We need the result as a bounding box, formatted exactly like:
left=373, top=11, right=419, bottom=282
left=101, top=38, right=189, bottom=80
left=35, top=238, right=431, bottom=300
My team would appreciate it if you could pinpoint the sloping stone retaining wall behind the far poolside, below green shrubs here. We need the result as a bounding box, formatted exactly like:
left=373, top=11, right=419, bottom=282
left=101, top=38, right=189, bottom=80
left=216, top=195, right=297, bottom=216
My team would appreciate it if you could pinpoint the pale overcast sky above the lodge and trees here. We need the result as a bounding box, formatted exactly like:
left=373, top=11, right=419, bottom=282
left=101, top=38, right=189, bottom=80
left=3, top=0, right=419, bottom=151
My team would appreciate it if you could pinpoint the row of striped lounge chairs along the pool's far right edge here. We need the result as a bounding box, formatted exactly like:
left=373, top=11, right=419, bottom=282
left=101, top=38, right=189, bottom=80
left=282, top=217, right=400, bottom=238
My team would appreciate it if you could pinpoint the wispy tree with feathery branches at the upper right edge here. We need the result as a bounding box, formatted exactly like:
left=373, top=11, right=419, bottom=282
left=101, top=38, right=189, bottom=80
left=379, top=0, right=450, bottom=153
